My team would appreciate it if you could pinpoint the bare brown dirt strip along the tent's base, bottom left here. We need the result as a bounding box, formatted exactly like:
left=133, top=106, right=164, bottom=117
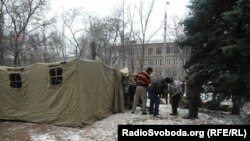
left=0, top=121, right=88, bottom=141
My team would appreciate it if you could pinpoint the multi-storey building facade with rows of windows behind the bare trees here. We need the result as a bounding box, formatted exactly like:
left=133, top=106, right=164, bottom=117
left=115, top=42, right=190, bottom=80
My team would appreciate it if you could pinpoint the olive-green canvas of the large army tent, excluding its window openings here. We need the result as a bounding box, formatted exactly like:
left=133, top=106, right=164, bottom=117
left=0, top=59, right=124, bottom=126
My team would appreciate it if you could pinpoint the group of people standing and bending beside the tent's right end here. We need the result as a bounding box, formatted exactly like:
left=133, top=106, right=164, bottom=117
left=121, top=67, right=184, bottom=116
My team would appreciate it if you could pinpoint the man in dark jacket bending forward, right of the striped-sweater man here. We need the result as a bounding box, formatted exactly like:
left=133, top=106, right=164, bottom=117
left=148, top=78, right=168, bottom=116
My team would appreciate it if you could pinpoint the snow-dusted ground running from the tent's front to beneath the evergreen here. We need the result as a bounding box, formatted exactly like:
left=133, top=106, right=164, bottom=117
left=0, top=99, right=250, bottom=141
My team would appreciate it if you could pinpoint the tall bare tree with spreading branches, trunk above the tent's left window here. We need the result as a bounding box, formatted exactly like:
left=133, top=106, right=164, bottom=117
left=3, top=0, right=47, bottom=66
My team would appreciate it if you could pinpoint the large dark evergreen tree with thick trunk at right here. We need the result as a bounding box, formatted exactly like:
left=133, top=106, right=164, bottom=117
left=180, top=0, right=250, bottom=117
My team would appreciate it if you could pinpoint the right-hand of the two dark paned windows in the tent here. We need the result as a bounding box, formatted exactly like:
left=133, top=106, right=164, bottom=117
left=49, top=68, right=63, bottom=85
